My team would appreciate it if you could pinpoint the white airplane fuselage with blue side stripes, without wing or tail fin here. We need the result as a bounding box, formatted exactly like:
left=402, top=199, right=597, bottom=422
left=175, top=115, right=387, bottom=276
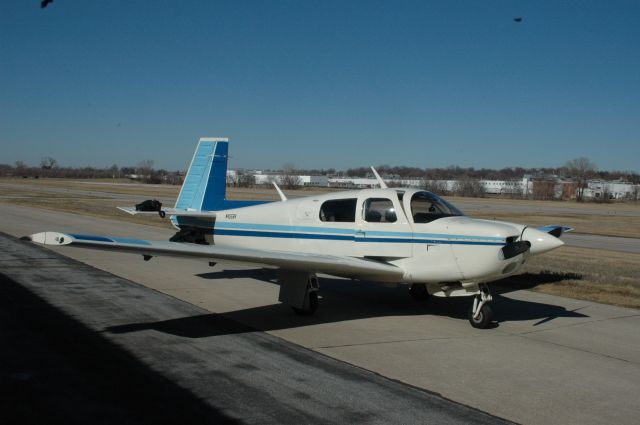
left=174, top=189, right=562, bottom=284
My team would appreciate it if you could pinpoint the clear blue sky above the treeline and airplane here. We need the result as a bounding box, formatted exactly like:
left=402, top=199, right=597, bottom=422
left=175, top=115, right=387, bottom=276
left=0, top=0, right=640, bottom=172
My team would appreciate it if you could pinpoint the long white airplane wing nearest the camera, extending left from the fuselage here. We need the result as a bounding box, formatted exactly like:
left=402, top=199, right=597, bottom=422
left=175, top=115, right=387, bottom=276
left=23, top=232, right=403, bottom=280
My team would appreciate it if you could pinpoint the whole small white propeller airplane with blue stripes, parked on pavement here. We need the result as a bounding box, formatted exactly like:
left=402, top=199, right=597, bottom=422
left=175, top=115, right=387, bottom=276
left=25, top=138, right=573, bottom=328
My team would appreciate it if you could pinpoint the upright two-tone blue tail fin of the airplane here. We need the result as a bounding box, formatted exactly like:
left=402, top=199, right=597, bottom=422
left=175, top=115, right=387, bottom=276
left=176, top=137, right=229, bottom=211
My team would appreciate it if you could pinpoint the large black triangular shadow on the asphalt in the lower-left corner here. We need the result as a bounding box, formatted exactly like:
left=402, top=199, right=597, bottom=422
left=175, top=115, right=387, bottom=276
left=0, top=273, right=240, bottom=425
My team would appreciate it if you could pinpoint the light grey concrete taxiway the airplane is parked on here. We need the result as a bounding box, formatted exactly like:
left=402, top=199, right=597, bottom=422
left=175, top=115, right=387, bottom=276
left=0, top=205, right=640, bottom=424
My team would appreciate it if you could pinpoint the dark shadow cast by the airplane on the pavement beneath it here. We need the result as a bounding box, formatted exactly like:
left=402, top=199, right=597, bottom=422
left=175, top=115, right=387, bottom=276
left=106, top=268, right=588, bottom=338
